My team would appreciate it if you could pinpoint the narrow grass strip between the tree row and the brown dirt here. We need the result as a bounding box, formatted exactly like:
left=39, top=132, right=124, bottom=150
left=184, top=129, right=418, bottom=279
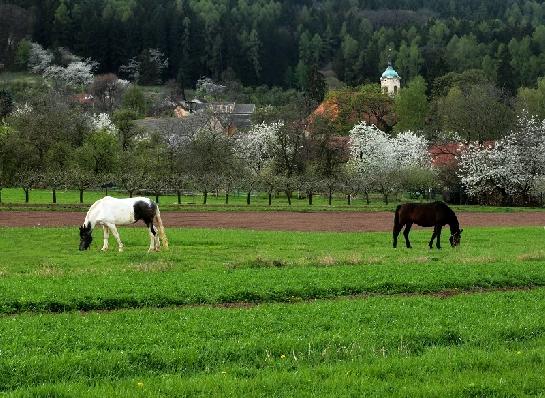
left=0, top=188, right=545, bottom=212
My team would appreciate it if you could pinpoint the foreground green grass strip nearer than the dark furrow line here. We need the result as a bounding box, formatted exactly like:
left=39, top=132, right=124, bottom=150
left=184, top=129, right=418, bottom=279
left=0, top=289, right=545, bottom=396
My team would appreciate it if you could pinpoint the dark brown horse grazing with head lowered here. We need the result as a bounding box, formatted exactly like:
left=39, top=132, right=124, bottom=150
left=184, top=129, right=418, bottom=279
left=394, top=202, right=463, bottom=249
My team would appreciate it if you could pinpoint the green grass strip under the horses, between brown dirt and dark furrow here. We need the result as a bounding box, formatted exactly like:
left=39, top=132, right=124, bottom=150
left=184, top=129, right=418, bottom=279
left=0, top=228, right=545, bottom=314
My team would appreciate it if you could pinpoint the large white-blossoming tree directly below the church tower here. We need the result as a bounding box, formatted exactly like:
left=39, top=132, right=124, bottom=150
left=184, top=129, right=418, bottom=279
left=349, top=122, right=431, bottom=203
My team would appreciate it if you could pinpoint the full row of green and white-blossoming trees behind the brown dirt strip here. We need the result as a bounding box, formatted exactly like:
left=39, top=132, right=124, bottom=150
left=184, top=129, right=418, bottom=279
left=0, top=85, right=545, bottom=204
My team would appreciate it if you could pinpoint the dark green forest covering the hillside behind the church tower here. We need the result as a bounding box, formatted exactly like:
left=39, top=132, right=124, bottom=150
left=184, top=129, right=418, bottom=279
left=0, top=0, right=545, bottom=93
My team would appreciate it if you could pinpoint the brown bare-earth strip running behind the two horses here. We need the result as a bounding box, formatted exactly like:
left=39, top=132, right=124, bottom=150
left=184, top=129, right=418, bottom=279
left=0, top=211, right=545, bottom=232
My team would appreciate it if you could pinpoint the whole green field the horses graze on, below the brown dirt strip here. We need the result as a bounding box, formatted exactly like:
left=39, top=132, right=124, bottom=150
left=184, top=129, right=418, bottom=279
left=0, top=228, right=545, bottom=397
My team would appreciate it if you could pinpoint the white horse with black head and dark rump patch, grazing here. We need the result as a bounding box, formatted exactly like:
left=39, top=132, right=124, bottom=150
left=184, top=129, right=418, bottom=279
left=79, top=196, right=168, bottom=252
